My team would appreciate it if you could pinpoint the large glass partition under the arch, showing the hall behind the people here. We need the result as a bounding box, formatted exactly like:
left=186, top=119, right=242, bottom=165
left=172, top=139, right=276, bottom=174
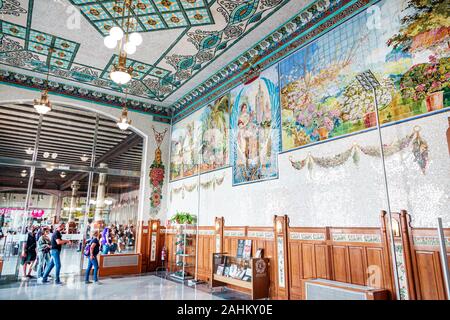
left=0, top=104, right=143, bottom=280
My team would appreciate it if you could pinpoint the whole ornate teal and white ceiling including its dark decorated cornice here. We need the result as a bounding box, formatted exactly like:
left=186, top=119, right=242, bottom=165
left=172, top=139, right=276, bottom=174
left=0, top=0, right=358, bottom=120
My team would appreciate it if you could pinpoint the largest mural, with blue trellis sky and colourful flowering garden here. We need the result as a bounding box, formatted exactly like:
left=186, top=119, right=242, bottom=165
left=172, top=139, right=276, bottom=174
left=280, top=0, right=450, bottom=150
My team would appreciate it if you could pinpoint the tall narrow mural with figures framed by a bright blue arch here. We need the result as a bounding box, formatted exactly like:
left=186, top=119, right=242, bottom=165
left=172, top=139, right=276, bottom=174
left=230, top=66, right=281, bottom=185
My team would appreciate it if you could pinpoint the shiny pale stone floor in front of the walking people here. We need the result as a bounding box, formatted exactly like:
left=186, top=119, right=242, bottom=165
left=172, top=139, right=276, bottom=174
left=0, top=275, right=222, bottom=300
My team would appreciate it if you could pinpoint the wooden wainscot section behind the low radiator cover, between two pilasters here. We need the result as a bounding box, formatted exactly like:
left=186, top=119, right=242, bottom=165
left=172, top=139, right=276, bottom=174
left=288, top=221, right=394, bottom=299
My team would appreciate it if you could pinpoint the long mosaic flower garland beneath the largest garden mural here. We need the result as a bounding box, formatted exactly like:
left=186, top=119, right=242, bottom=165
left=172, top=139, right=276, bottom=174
left=289, top=126, right=428, bottom=174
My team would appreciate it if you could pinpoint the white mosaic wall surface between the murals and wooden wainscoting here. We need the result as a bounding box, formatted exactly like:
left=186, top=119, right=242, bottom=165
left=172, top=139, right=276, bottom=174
left=168, top=110, right=450, bottom=227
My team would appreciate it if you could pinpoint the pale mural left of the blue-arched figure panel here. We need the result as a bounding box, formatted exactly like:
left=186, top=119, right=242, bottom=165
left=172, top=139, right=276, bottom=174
left=170, top=95, right=230, bottom=179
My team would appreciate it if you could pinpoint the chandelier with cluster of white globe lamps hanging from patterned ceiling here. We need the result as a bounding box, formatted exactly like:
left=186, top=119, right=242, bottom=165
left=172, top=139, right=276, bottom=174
left=104, top=0, right=142, bottom=85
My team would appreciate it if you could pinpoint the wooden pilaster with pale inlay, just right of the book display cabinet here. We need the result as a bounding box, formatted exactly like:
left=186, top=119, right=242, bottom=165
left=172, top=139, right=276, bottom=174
left=272, top=215, right=289, bottom=300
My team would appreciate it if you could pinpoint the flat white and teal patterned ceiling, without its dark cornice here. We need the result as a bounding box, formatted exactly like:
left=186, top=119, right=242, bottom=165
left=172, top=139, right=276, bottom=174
left=0, top=0, right=306, bottom=115
